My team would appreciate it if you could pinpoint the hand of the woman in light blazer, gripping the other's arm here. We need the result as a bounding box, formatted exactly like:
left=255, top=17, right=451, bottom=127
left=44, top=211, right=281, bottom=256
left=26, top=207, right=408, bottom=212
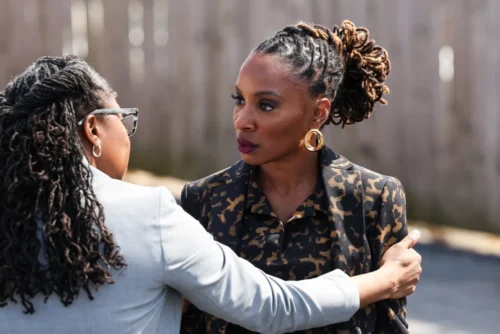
left=379, top=230, right=422, bottom=299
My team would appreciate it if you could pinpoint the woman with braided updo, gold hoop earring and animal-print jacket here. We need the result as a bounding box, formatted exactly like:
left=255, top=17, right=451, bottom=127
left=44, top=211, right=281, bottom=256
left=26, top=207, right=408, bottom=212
left=182, top=21, right=420, bottom=334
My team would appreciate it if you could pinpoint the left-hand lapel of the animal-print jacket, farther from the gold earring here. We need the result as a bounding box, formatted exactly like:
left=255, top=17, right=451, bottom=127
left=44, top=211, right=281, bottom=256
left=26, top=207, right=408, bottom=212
left=207, top=162, right=249, bottom=251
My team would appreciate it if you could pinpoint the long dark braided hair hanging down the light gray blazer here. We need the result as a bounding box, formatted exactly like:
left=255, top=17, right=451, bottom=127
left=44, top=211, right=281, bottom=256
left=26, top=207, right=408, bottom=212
left=0, top=56, right=126, bottom=314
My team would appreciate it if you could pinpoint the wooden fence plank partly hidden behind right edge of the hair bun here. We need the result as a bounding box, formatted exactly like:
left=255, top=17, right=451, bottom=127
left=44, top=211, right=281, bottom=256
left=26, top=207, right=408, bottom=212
left=368, top=0, right=412, bottom=180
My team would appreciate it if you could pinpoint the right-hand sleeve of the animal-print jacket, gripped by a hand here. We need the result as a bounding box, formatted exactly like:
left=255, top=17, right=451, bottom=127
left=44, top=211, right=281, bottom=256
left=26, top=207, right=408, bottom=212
left=370, top=177, right=409, bottom=334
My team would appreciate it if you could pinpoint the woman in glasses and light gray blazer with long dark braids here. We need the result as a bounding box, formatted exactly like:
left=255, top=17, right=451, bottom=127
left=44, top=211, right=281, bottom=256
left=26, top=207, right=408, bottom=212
left=0, top=56, right=421, bottom=334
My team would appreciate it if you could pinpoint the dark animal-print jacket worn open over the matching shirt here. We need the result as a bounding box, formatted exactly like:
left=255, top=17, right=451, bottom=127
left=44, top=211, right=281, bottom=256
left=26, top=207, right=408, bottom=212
left=181, top=148, right=408, bottom=333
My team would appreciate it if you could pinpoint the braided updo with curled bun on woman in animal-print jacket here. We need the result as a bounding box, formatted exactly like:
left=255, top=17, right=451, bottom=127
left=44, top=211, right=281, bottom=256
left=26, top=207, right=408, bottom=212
left=254, top=21, right=391, bottom=127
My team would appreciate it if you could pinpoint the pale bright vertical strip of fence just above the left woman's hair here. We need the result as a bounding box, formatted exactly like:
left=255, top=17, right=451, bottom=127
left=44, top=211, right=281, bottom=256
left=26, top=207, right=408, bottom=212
left=70, top=0, right=89, bottom=58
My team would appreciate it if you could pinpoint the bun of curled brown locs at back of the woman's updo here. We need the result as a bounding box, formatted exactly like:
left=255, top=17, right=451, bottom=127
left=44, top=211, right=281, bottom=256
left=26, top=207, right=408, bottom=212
left=329, top=20, right=391, bottom=125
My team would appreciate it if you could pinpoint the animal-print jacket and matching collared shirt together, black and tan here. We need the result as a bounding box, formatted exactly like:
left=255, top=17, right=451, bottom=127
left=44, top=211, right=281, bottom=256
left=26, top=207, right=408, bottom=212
left=181, top=148, right=409, bottom=334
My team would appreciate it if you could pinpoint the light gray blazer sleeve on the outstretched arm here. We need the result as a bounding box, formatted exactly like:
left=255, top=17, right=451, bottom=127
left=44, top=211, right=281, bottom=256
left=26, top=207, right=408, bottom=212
left=159, top=188, right=359, bottom=333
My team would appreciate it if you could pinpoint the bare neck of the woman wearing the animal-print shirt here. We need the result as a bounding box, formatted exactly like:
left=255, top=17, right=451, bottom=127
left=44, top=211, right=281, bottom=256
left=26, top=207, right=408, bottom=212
left=259, top=150, right=319, bottom=195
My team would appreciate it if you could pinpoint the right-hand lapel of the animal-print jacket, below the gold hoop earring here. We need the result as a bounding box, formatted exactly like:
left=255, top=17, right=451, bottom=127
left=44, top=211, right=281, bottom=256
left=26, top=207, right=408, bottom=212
left=321, top=149, right=369, bottom=276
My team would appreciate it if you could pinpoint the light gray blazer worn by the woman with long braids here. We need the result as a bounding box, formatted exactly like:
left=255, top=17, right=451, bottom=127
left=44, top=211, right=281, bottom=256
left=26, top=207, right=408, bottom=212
left=0, top=168, right=359, bottom=334
